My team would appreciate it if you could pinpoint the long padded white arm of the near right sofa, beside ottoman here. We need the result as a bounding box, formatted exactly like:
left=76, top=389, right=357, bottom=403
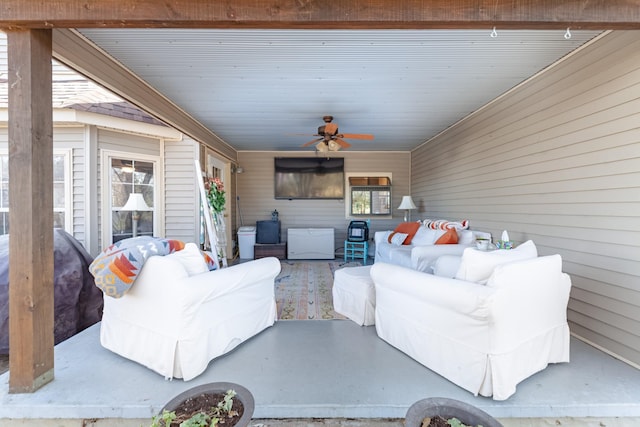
left=371, top=262, right=495, bottom=318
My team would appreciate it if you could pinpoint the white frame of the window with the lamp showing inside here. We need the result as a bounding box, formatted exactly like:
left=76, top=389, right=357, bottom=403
left=100, top=150, right=164, bottom=247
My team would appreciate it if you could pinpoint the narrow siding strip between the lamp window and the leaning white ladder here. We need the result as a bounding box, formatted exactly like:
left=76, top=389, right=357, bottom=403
left=164, top=139, right=200, bottom=243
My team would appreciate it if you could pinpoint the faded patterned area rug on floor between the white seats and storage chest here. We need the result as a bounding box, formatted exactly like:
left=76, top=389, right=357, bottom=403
left=275, top=260, right=362, bottom=320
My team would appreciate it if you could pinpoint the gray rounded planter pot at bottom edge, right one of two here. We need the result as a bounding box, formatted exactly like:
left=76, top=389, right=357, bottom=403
left=404, top=397, right=503, bottom=427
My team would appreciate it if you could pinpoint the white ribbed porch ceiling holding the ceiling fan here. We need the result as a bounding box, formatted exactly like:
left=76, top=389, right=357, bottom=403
left=74, top=29, right=599, bottom=151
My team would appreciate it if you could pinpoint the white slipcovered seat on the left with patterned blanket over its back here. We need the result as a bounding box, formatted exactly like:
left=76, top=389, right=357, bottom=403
left=100, top=244, right=280, bottom=381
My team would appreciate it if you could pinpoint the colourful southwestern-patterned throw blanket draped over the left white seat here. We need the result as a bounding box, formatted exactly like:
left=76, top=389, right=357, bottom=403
left=89, top=236, right=184, bottom=298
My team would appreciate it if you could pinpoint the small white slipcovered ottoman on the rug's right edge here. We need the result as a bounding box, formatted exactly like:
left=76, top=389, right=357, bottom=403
left=333, top=265, right=376, bottom=326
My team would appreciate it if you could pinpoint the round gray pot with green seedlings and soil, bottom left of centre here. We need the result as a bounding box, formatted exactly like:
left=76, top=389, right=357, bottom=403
left=150, top=382, right=255, bottom=427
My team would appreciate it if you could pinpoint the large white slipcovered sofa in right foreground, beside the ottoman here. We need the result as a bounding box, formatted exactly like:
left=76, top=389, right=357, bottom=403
left=371, top=242, right=571, bottom=400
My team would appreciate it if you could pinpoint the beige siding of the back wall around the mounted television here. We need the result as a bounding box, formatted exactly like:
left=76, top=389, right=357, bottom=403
left=237, top=151, right=410, bottom=249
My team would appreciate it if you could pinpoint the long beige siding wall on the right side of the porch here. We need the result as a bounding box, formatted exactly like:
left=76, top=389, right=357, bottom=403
left=411, top=32, right=640, bottom=364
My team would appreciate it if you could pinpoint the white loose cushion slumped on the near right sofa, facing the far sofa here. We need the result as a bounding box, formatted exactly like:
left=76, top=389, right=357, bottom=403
left=456, top=240, right=538, bottom=285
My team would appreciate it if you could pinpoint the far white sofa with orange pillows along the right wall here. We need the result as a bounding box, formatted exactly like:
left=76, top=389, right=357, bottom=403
left=374, top=225, right=491, bottom=273
